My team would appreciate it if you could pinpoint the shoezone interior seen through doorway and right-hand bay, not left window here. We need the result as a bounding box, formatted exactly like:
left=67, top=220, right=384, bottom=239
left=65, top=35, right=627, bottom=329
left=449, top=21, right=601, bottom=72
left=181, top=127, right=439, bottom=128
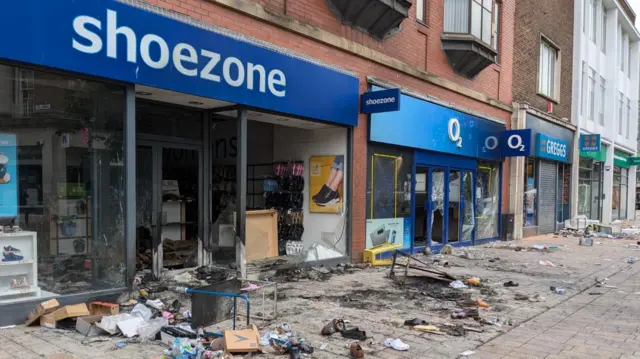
left=136, top=87, right=348, bottom=273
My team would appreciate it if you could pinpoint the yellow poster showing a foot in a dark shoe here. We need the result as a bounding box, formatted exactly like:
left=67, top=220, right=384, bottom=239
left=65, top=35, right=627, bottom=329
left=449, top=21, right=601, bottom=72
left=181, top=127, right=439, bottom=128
left=309, top=155, right=345, bottom=213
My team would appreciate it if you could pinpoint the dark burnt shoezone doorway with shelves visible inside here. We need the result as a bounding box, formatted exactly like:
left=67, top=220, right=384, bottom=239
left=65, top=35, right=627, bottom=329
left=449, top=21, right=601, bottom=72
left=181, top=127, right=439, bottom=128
left=137, top=141, right=202, bottom=274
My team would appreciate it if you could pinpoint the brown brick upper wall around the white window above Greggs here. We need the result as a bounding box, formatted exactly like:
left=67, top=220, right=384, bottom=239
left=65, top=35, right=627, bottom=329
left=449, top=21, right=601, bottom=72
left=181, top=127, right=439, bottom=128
left=513, top=0, right=573, bottom=119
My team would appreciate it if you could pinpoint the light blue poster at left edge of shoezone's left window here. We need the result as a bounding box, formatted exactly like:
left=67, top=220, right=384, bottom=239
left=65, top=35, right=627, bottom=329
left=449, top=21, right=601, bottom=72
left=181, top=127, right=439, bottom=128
left=0, top=133, right=18, bottom=218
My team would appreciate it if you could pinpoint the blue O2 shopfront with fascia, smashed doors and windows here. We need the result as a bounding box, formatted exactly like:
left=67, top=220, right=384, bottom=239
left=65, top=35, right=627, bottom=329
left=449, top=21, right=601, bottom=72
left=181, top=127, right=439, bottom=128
left=366, top=86, right=505, bottom=252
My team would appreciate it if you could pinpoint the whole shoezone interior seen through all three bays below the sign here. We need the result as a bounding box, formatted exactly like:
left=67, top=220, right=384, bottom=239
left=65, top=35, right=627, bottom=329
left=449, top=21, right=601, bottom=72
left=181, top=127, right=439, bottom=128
left=0, top=64, right=349, bottom=303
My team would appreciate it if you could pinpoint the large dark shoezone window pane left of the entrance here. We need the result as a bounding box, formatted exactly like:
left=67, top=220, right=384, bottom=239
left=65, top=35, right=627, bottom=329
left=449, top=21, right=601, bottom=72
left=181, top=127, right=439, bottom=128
left=0, top=64, right=126, bottom=302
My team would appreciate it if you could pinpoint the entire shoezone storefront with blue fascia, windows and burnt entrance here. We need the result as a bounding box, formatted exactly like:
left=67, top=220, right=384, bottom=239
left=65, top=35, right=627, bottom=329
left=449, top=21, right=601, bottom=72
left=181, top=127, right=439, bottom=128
left=0, top=0, right=359, bottom=325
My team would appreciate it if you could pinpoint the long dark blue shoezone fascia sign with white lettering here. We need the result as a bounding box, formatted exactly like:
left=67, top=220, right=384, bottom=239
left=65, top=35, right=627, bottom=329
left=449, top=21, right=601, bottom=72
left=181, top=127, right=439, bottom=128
left=0, top=0, right=360, bottom=125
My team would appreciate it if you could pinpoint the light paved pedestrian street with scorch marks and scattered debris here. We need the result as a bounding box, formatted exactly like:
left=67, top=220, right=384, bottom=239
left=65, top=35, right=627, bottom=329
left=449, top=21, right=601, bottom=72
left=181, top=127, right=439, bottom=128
left=0, top=226, right=640, bottom=359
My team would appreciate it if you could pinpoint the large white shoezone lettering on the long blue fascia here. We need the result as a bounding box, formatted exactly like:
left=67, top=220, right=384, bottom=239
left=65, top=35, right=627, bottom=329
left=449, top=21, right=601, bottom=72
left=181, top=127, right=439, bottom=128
left=72, top=10, right=288, bottom=97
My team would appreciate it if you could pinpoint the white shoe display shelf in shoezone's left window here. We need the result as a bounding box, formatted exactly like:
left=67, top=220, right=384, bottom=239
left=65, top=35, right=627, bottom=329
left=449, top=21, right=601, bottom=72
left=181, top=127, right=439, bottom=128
left=0, top=231, right=40, bottom=302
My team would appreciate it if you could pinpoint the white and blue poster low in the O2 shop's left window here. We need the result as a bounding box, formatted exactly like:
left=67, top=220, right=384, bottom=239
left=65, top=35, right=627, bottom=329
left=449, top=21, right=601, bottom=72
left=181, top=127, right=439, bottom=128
left=365, top=218, right=411, bottom=249
